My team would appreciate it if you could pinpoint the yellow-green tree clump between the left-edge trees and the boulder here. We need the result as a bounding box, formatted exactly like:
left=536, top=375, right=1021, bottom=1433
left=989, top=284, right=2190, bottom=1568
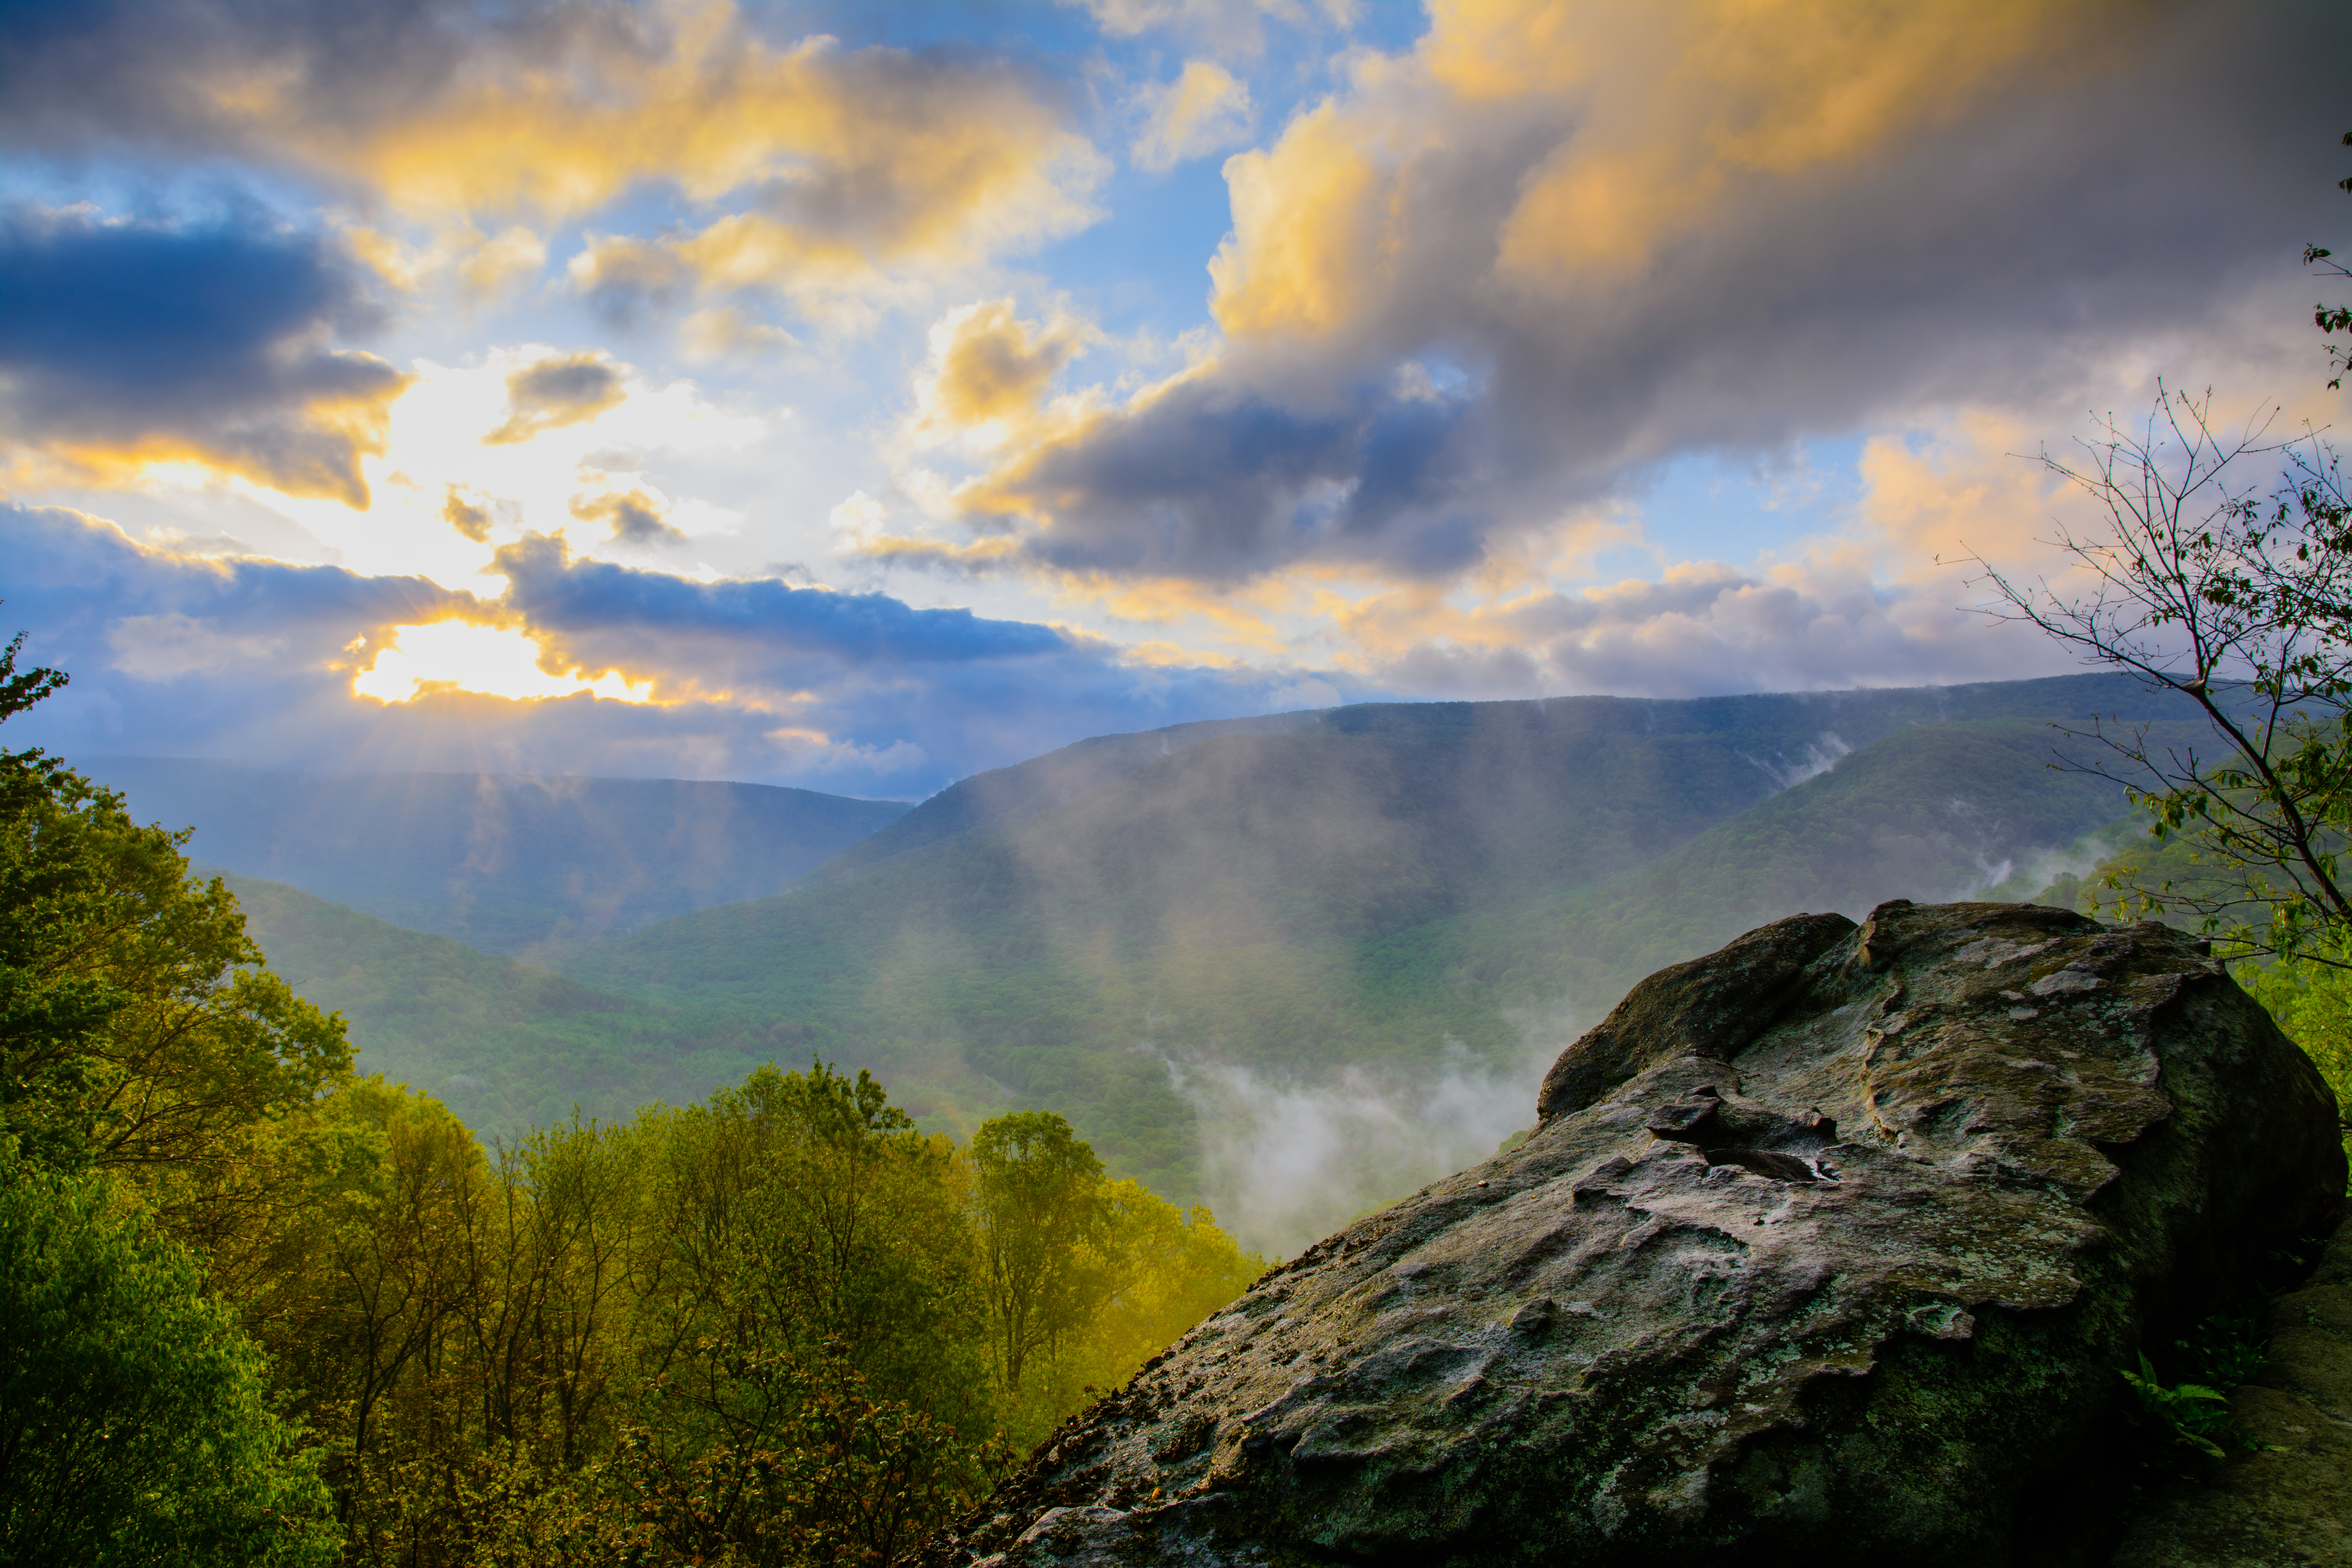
left=285, top=1063, right=1263, bottom=1563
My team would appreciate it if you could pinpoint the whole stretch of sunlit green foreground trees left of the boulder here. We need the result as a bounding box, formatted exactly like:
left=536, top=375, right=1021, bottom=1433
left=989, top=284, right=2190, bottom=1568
left=0, top=642, right=1263, bottom=1568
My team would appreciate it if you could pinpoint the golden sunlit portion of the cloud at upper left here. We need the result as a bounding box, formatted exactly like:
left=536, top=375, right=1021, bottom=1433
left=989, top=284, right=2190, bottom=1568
left=275, top=2, right=1103, bottom=303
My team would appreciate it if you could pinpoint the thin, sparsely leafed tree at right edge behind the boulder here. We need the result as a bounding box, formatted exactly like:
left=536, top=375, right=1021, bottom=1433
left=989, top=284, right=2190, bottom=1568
left=1971, top=388, right=2352, bottom=962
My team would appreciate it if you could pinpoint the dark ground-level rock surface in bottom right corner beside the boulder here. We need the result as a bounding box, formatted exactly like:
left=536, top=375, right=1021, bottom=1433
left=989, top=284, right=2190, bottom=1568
left=2114, top=1225, right=2352, bottom=1568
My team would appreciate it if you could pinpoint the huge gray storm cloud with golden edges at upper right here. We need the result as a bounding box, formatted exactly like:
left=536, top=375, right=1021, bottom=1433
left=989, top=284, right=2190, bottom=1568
left=967, top=5, right=2352, bottom=583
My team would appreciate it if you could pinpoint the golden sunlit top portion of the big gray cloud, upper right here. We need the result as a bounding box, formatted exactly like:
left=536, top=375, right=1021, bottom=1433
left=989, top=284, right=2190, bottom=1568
left=1211, top=0, right=2131, bottom=339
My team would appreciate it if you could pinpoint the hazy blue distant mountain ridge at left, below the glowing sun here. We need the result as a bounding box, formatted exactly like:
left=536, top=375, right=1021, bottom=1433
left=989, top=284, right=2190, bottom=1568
left=78, top=757, right=906, bottom=955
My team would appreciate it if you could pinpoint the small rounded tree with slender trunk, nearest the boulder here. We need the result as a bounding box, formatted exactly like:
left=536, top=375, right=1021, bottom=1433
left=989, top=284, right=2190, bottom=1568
left=967, top=1110, right=1110, bottom=1394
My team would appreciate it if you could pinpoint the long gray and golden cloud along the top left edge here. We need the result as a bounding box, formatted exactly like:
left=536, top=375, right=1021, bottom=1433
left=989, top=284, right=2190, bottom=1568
left=0, top=0, right=1103, bottom=322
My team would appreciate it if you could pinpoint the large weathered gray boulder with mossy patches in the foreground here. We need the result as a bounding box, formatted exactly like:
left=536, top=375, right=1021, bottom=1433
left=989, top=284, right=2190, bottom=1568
left=922, top=903, right=2345, bottom=1568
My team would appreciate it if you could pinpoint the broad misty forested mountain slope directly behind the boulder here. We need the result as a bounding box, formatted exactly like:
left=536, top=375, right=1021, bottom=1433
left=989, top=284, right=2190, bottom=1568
left=567, top=682, right=2201, bottom=1246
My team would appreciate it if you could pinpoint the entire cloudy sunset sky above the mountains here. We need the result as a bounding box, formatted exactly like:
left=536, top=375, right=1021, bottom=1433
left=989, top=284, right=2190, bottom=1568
left=0, top=0, right=2352, bottom=797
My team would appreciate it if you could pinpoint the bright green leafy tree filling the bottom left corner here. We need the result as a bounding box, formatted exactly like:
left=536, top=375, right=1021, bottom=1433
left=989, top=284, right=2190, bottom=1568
left=0, top=1145, right=341, bottom=1566
